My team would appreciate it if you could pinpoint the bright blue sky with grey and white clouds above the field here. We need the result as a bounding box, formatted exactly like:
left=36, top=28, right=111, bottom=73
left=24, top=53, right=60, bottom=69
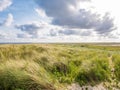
left=0, top=0, right=120, bottom=43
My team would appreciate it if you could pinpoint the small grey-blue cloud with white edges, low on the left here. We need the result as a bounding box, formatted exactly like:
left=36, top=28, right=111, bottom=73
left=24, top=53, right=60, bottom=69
left=15, top=22, right=57, bottom=38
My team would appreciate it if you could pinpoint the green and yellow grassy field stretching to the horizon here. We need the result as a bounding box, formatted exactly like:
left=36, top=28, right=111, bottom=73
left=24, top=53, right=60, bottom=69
left=0, top=44, right=120, bottom=90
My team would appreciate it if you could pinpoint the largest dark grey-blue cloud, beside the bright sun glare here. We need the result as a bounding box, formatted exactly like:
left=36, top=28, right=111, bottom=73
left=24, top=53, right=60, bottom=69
left=36, top=0, right=115, bottom=34
